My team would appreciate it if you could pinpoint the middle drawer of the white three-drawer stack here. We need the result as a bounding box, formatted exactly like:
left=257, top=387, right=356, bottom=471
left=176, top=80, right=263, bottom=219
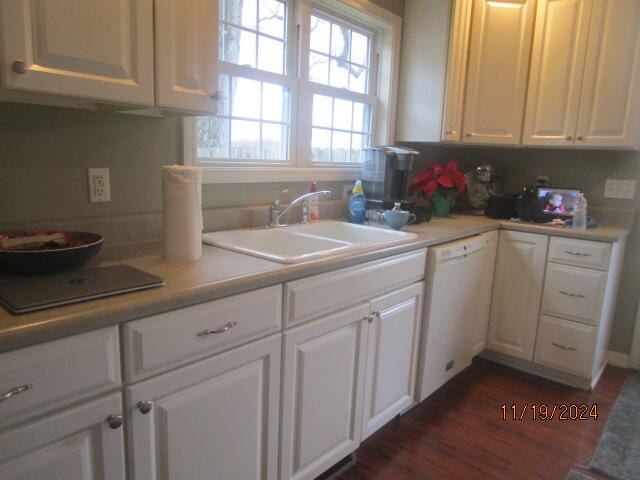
left=542, top=263, right=607, bottom=325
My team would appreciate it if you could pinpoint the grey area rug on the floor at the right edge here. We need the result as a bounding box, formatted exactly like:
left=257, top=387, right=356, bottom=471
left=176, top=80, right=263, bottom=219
left=589, top=372, right=640, bottom=480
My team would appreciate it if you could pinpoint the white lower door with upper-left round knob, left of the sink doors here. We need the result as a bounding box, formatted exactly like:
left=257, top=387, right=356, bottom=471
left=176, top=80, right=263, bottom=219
left=127, top=334, right=281, bottom=480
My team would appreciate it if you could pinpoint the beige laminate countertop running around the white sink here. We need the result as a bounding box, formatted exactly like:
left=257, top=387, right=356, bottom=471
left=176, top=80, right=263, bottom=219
left=0, top=215, right=630, bottom=352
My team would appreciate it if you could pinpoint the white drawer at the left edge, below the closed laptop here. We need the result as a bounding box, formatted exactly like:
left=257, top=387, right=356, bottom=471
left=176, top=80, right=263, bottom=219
left=0, top=326, right=120, bottom=426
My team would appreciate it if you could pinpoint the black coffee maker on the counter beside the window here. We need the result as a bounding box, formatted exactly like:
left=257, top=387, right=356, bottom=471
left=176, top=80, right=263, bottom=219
left=361, top=145, right=420, bottom=210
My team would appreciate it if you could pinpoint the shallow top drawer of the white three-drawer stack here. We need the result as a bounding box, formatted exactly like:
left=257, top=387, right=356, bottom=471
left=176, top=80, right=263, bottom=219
left=548, top=237, right=611, bottom=270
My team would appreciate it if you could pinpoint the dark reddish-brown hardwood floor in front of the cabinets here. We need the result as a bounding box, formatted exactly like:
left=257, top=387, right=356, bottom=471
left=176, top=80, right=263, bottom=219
left=339, top=359, right=628, bottom=480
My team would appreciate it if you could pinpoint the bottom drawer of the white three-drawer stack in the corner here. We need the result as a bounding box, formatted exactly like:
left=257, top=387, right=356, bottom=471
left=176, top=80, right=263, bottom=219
left=535, top=315, right=598, bottom=378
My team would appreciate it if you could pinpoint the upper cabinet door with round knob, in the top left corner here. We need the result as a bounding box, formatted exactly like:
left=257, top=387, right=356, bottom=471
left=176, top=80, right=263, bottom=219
left=0, top=0, right=153, bottom=105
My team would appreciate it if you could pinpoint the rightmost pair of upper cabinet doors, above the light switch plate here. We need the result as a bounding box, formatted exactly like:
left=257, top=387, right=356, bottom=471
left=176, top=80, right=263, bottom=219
left=523, top=0, right=640, bottom=148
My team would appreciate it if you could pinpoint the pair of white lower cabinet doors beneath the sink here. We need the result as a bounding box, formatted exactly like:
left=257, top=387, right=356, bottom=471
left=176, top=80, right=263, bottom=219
left=281, top=282, right=424, bottom=480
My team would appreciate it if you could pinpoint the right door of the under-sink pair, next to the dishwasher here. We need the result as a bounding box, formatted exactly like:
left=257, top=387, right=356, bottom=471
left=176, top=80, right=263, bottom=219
left=362, top=282, right=424, bottom=440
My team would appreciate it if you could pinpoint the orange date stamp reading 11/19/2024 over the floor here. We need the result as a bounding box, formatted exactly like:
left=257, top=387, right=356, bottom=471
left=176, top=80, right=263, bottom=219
left=500, top=403, right=598, bottom=421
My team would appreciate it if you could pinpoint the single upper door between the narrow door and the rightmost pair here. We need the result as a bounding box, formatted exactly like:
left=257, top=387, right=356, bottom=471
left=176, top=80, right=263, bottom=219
left=464, top=0, right=535, bottom=145
